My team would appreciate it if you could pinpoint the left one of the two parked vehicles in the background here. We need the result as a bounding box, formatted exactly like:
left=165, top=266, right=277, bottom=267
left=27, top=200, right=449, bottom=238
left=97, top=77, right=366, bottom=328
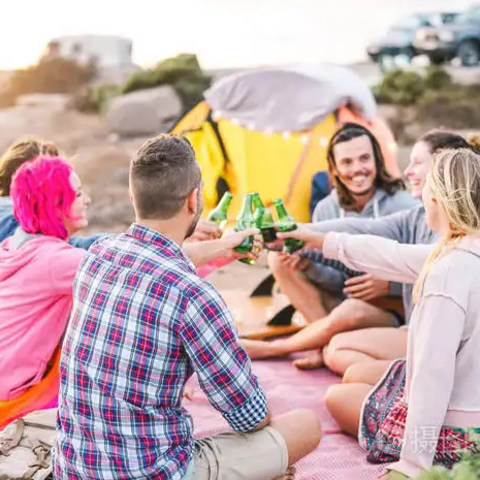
left=367, top=12, right=457, bottom=68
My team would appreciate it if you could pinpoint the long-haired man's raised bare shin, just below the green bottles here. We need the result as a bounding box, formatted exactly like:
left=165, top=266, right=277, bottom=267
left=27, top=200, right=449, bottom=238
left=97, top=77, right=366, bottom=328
left=267, top=252, right=328, bottom=323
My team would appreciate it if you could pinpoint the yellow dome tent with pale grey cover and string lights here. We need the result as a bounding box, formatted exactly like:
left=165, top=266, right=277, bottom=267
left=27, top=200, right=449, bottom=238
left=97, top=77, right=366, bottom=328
left=172, top=66, right=399, bottom=222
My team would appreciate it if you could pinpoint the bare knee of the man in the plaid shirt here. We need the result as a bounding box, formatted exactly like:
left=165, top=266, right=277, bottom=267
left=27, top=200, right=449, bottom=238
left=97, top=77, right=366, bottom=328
left=270, top=409, right=322, bottom=465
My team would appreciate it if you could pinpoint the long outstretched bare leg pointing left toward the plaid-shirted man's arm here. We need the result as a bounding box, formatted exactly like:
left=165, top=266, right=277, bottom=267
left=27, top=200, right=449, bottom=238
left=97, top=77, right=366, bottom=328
left=240, top=299, right=392, bottom=367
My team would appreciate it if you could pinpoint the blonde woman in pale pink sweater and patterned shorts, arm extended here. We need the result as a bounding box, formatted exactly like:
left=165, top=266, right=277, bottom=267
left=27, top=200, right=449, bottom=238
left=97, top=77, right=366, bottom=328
left=284, top=149, right=480, bottom=479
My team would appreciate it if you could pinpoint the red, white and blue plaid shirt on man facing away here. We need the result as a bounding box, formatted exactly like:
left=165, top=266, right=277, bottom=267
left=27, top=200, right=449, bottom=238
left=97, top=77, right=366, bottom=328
left=54, top=224, right=267, bottom=480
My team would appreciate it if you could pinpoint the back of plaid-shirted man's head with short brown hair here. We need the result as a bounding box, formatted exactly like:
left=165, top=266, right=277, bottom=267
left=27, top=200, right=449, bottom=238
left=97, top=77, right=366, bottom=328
left=130, top=135, right=202, bottom=220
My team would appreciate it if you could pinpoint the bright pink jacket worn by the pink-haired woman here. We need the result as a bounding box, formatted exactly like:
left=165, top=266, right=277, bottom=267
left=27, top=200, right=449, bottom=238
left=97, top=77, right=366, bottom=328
left=0, top=229, right=86, bottom=400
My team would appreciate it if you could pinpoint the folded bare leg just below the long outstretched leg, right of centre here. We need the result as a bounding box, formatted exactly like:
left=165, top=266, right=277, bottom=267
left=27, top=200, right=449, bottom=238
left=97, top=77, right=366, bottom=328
left=323, top=328, right=408, bottom=375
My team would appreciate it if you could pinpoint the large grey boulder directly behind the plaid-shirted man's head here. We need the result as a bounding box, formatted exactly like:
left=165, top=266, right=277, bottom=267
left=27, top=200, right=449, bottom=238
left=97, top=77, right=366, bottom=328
left=107, top=86, right=182, bottom=136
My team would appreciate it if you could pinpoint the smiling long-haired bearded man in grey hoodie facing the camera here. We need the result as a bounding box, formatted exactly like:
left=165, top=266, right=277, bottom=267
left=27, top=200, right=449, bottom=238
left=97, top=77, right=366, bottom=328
left=269, top=123, right=418, bottom=322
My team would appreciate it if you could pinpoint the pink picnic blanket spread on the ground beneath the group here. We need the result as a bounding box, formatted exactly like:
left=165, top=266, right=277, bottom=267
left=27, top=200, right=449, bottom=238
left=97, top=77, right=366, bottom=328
left=184, top=360, right=383, bottom=480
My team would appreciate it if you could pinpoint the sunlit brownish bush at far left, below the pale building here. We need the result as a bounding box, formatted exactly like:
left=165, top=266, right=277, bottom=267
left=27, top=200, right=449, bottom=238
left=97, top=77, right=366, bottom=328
left=0, top=58, right=95, bottom=106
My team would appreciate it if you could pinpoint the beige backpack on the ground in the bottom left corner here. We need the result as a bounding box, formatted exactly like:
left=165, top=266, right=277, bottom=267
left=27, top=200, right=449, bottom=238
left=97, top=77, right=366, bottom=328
left=0, top=408, right=57, bottom=480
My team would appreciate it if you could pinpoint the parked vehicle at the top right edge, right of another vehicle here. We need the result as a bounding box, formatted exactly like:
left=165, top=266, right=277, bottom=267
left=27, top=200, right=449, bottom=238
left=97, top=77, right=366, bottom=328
left=414, top=5, right=480, bottom=67
